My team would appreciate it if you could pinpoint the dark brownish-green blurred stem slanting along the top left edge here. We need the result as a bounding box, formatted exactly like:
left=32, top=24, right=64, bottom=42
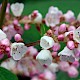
left=0, top=0, right=8, bottom=28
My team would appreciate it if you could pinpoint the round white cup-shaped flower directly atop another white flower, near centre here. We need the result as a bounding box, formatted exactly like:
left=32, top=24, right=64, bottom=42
left=40, top=36, right=54, bottom=49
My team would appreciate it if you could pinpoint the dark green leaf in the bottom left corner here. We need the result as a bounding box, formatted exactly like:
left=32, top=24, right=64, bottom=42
left=0, top=67, right=18, bottom=80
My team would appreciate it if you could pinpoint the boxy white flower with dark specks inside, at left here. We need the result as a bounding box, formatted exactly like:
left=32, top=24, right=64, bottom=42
left=10, top=43, right=27, bottom=60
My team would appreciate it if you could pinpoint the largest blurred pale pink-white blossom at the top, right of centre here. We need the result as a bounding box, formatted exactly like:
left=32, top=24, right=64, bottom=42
left=45, top=6, right=62, bottom=27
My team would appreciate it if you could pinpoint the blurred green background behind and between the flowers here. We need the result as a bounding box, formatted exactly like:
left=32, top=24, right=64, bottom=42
left=0, top=0, right=80, bottom=80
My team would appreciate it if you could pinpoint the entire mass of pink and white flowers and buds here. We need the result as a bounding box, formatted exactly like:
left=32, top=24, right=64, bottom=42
left=0, top=3, right=80, bottom=80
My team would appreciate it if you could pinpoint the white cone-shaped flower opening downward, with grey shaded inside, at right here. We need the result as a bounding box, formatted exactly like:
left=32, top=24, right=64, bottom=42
left=58, top=47, right=75, bottom=62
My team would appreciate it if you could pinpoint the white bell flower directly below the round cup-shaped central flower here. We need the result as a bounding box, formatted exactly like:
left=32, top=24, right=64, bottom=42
left=36, top=50, right=52, bottom=66
